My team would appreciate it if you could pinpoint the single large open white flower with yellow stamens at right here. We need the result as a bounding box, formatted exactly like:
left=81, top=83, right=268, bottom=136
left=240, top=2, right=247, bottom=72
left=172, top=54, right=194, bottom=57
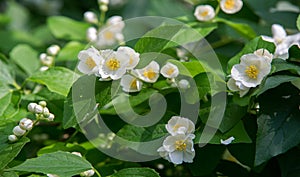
left=231, top=54, right=271, bottom=87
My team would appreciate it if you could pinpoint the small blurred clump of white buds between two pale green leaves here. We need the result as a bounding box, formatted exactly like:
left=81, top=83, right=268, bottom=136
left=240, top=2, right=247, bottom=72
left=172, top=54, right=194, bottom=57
left=39, top=45, right=60, bottom=71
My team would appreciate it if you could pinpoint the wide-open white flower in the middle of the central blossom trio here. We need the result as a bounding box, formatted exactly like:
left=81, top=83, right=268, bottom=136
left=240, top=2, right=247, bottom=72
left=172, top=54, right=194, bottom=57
left=99, top=50, right=129, bottom=80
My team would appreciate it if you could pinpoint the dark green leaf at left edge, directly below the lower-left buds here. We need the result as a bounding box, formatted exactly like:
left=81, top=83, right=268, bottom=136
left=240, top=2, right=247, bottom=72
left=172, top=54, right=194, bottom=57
left=0, top=136, right=29, bottom=171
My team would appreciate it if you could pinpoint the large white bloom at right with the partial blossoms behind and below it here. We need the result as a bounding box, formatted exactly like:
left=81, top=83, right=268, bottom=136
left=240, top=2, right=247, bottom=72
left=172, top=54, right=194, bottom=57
left=227, top=49, right=273, bottom=97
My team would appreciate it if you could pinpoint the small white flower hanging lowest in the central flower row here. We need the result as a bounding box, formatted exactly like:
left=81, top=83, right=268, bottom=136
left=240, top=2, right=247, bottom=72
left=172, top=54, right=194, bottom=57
left=120, top=74, right=143, bottom=92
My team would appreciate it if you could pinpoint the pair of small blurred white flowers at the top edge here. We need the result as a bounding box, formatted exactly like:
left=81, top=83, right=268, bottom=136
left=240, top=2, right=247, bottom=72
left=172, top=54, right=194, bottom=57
left=194, top=0, right=243, bottom=21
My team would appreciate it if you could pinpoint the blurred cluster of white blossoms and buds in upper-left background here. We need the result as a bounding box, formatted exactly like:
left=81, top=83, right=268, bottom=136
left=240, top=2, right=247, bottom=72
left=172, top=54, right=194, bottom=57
left=84, top=12, right=125, bottom=49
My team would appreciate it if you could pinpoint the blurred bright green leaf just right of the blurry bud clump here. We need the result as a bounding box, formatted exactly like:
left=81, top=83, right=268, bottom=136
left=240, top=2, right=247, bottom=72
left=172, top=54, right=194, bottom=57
left=56, top=41, right=86, bottom=62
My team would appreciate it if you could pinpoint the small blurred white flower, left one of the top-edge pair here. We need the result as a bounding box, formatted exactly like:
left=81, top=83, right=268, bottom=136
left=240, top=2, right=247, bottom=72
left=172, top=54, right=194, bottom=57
left=194, top=5, right=216, bottom=21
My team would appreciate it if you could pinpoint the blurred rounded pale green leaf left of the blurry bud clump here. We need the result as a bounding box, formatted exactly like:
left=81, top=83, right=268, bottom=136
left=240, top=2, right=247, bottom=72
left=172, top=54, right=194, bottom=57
left=9, top=44, right=40, bottom=75
